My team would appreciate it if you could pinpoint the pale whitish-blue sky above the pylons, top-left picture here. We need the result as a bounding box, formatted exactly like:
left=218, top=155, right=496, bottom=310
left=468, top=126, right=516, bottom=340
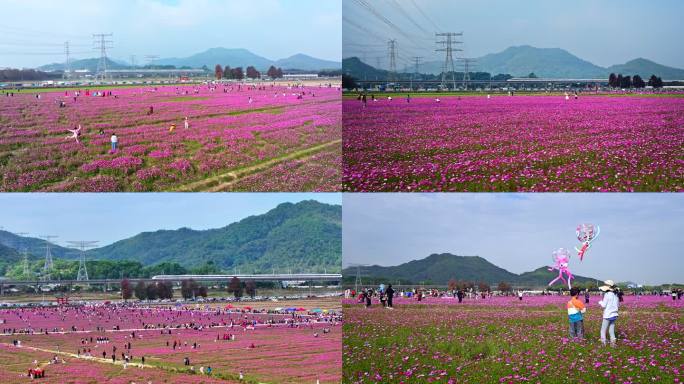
left=0, top=0, right=342, bottom=67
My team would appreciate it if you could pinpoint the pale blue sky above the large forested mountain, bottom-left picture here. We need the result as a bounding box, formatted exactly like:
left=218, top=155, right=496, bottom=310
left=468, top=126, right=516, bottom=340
left=0, top=193, right=341, bottom=245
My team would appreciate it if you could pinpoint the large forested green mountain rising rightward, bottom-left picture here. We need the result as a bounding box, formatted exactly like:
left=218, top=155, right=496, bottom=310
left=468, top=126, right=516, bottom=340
left=88, top=201, right=342, bottom=273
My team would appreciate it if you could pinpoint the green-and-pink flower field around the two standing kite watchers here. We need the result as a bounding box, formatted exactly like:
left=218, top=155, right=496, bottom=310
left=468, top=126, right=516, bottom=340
left=342, top=296, right=684, bottom=383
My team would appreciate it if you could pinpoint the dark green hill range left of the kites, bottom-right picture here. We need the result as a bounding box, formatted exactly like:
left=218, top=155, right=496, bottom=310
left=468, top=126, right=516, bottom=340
left=342, top=253, right=594, bottom=287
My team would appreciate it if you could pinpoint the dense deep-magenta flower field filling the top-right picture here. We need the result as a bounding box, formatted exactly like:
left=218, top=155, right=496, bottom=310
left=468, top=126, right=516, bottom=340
left=343, top=95, right=684, bottom=192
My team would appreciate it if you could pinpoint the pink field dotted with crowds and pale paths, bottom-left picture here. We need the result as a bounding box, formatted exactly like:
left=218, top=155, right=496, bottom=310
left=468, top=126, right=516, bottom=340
left=0, top=301, right=342, bottom=383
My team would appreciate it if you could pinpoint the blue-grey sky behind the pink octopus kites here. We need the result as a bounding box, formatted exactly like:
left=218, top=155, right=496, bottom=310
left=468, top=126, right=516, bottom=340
left=342, top=193, right=684, bottom=284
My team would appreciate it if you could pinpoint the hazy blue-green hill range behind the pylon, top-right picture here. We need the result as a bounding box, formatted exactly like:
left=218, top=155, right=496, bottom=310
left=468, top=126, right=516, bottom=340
left=342, top=45, right=684, bottom=80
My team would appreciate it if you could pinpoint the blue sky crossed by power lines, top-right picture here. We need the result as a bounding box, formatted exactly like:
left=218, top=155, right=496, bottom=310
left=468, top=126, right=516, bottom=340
left=343, top=0, right=684, bottom=68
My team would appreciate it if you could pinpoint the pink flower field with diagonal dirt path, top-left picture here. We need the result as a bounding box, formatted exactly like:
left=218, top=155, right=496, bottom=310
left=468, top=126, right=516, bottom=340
left=0, top=84, right=342, bottom=192
